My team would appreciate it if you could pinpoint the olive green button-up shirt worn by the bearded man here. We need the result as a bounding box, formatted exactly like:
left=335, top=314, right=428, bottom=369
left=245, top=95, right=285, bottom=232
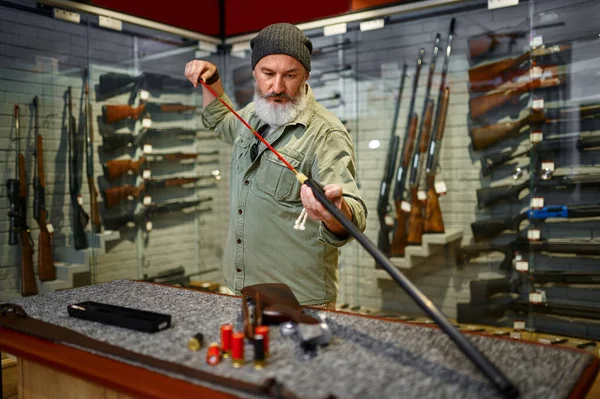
left=202, top=85, right=367, bottom=305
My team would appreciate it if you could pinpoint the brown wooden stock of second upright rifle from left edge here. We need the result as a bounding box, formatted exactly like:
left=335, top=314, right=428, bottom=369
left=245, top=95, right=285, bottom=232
left=33, top=135, right=56, bottom=281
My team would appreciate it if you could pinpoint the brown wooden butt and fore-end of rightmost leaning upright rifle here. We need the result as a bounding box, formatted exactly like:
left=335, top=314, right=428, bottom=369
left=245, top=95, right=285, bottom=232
left=423, top=87, right=450, bottom=234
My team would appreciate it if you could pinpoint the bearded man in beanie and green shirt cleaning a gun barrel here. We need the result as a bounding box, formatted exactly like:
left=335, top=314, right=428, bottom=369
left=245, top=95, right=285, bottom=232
left=185, top=23, right=367, bottom=308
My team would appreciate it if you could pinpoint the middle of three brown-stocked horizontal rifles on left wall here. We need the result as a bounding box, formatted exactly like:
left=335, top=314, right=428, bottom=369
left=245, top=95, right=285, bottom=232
left=103, top=150, right=219, bottom=180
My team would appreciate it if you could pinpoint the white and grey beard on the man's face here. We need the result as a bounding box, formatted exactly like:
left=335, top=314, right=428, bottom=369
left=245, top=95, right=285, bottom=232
left=254, top=82, right=308, bottom=128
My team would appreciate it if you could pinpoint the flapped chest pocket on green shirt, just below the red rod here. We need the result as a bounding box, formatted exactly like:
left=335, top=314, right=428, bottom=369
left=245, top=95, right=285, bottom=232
left=257, top=150, right=300, bottom=201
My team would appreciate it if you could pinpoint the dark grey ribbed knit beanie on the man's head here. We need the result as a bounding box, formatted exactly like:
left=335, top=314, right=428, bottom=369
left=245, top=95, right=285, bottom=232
left=250, top=23, right=312, bottom=72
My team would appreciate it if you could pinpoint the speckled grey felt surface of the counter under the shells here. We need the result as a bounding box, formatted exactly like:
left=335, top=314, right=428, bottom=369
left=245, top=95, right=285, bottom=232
left=2, top=280, right=594, bottom=399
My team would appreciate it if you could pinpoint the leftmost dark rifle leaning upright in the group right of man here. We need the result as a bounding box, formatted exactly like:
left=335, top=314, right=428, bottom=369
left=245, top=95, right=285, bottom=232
left=377, top=64, right=408, bottom=254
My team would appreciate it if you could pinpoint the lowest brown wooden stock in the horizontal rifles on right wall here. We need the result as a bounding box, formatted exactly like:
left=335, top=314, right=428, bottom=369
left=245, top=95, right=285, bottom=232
left=470, top=110, right=545, bottom=151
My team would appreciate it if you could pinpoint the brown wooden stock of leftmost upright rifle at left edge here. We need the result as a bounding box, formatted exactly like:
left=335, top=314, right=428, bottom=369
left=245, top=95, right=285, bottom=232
left=19, top=153, right=37, bottom=296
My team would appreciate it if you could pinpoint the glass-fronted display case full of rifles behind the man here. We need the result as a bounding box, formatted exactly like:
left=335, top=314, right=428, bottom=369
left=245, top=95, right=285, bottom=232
left=0, top=0, right=600, bottom=339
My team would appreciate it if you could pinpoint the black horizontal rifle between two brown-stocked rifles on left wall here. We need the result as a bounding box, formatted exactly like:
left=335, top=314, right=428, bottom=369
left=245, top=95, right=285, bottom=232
left=102, top=127, right=215, bottom=152
